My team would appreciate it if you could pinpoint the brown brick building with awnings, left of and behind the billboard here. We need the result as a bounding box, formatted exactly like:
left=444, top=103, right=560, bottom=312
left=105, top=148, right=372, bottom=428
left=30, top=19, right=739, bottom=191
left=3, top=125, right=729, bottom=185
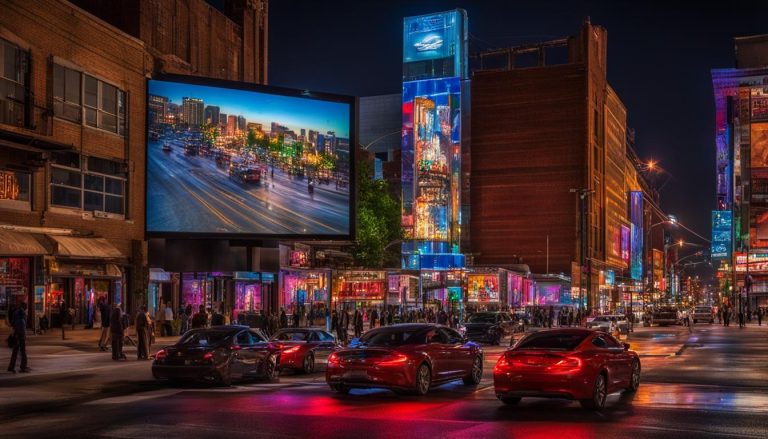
left=0, top=0, right=267, bottom=325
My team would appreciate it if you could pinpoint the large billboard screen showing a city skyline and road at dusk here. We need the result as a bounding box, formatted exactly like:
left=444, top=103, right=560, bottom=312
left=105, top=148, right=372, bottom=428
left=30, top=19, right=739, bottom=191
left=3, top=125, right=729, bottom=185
left=146, top=76, right=354, bottom=238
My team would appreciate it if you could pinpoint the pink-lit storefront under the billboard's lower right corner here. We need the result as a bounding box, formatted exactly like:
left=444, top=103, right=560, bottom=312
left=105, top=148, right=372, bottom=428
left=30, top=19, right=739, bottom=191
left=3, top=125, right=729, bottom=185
left=280, top=268, right=331, bottom=325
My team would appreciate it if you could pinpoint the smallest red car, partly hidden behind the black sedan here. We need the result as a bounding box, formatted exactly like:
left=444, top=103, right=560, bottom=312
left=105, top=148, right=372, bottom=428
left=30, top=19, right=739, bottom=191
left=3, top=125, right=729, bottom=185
left=270, top=328, right=341, bottom=373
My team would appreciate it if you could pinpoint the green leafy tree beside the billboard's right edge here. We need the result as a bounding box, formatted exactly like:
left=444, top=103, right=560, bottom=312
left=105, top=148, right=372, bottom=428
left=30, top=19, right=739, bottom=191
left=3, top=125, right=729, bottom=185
left=352, top=162, right=403, bottom=268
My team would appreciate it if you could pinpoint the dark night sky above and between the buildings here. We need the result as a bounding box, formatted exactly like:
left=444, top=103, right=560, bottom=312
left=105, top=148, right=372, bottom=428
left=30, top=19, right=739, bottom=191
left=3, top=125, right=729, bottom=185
left=269, top=0, right=768, bottom=248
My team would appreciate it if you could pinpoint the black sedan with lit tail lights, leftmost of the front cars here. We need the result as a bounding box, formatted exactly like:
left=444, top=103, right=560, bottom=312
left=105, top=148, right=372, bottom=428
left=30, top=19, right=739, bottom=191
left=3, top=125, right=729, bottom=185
left=152, top=326, right=280, bottom=385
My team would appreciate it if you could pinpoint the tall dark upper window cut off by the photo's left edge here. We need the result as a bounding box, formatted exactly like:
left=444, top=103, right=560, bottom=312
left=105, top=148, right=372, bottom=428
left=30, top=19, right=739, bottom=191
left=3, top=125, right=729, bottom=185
left=0, top=39, right=29, bottom=127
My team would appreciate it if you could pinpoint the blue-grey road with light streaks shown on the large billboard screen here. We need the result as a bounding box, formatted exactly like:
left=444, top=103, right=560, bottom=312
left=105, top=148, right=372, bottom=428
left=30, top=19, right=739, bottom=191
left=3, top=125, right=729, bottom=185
left=147, top=136, right=349, bottom=235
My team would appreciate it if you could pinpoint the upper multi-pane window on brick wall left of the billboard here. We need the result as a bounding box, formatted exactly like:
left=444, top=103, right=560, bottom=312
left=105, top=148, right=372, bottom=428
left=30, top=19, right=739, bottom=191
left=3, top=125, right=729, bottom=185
left=53, top=64, right=126, bottom=136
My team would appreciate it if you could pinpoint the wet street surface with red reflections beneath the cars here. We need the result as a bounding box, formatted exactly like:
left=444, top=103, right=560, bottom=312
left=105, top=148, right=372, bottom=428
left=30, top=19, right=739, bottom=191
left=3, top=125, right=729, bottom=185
left=0, top=325, right=768, bottom=439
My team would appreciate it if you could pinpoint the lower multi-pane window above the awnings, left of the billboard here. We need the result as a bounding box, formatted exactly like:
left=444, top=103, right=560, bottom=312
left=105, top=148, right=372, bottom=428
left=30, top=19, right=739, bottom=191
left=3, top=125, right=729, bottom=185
left=51, top=152, right=126, bottom=215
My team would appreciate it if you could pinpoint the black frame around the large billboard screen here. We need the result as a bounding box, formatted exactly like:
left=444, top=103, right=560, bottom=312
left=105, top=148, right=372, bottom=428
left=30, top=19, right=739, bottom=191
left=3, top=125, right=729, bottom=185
left=143, top=74, right=359, bottom=241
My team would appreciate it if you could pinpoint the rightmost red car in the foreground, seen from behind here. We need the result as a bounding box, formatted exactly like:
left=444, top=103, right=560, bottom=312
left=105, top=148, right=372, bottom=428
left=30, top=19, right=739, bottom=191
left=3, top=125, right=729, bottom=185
left=493, top=328, right=640, bottom=409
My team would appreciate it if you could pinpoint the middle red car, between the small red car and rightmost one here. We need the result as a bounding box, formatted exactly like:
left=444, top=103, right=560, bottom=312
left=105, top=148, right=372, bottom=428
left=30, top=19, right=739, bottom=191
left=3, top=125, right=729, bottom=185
left=325, top=324, right=483, bottom=395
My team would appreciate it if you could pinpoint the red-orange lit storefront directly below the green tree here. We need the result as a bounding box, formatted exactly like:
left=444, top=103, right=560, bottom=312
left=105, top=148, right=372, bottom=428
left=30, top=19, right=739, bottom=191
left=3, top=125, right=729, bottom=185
left=331, top=270, right=387, bottom=310
